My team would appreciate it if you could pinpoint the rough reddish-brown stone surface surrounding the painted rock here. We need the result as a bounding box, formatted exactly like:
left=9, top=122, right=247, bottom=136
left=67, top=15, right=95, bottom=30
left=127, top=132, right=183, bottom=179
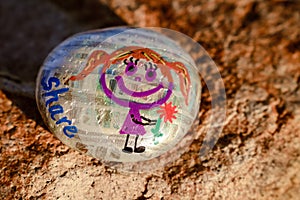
left=0, top=0, right=300, bottom=200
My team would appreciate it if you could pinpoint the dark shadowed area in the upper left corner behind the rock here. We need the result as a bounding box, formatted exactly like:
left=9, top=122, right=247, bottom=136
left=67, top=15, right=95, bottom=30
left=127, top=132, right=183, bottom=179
left=0, top=0, right=126, bottom=82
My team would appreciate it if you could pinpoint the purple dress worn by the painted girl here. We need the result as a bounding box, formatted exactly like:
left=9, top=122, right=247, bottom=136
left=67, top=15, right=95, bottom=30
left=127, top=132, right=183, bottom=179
left=120, top=108, right=146, bottom=135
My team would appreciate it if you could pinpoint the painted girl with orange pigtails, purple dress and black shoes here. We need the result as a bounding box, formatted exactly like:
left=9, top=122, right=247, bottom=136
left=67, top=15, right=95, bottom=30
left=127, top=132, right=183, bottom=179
left=70, top=46, right=190, bottom=153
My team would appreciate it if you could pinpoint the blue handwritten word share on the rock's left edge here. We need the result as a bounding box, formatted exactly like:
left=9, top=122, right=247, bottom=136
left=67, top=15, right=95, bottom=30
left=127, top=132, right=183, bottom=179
left=41, top=76, right=78, bottom=138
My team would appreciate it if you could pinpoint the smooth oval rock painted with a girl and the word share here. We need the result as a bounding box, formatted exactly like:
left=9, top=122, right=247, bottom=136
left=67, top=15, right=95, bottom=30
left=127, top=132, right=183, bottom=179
left=36, top=27, right=201, bottom=162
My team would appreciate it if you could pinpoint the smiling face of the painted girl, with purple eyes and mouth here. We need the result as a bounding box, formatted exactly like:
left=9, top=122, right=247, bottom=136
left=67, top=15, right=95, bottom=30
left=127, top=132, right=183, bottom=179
left=100, top=56, right=173, bottom=109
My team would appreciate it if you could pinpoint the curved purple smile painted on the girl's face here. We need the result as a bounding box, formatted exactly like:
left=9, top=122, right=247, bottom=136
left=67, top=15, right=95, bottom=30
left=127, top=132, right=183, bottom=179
left=115, top=76, right=163, bottom=97
